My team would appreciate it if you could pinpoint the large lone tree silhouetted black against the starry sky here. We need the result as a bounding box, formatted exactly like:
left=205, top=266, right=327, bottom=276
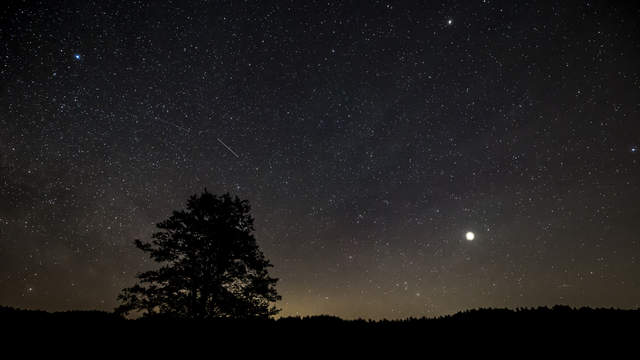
left=116, top=188, right=281, bottom=319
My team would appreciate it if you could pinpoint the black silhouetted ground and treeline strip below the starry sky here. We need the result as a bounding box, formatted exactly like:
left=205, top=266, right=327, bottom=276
left=0, top=306, right=640, bottom=359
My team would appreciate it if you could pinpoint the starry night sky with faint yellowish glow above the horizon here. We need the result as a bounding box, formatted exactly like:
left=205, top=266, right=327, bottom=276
left=0, top=0, right=640, bottom=319
